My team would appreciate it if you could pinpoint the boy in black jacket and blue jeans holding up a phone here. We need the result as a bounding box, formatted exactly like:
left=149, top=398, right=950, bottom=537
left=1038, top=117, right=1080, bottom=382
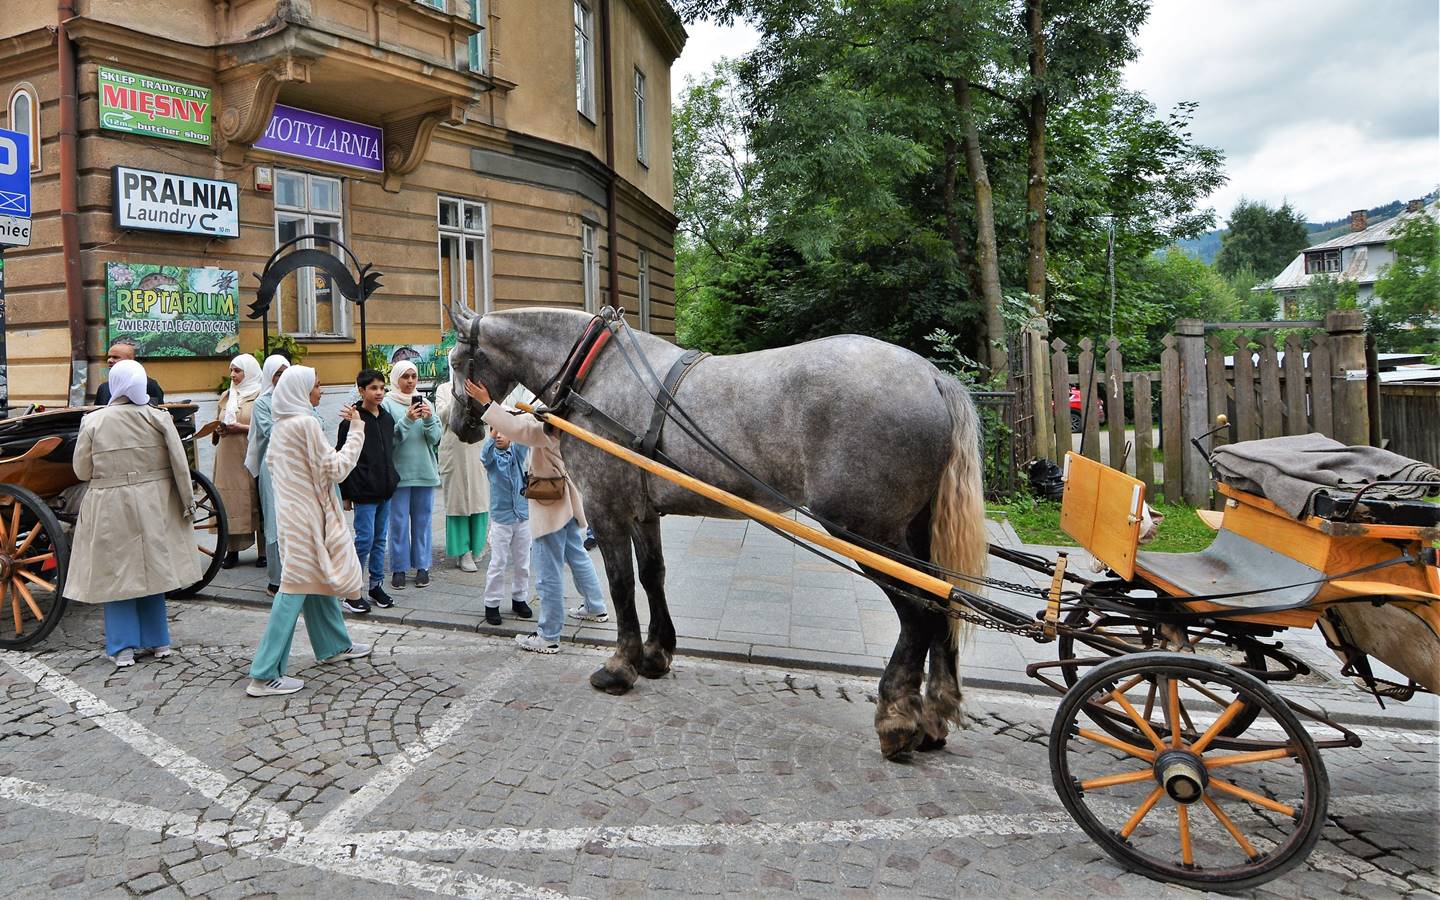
left=336, top=369, right=400, bottom=613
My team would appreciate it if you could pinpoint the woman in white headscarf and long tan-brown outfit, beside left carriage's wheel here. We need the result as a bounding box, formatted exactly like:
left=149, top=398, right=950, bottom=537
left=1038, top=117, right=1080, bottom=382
left=212, top=353, right=265, bottom=569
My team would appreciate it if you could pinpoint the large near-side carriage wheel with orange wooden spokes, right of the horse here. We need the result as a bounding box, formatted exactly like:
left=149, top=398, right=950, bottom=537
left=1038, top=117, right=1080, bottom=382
left=1050, top=652, right=1329, bottom=891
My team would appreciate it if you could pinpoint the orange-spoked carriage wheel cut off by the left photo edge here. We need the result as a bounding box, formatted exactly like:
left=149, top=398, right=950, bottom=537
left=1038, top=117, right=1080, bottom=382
left=0, top=484, right=71, bottom=649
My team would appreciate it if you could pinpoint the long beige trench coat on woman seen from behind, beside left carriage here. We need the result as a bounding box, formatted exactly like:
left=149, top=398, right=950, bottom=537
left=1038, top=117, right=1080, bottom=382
left=65, top=402, right=202, bottom=603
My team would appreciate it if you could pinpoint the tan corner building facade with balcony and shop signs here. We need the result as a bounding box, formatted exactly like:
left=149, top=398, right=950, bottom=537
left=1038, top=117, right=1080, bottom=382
left=0, top=0, right=685, bottom=405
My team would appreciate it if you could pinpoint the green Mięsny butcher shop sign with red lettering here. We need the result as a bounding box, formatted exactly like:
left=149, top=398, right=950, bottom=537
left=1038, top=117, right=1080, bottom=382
left=99, top=66, right=212, bottom=144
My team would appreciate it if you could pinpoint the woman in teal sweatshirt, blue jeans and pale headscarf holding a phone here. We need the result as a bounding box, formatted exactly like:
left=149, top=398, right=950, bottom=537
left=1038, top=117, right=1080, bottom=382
left=384, top=360, right=445, bottom=590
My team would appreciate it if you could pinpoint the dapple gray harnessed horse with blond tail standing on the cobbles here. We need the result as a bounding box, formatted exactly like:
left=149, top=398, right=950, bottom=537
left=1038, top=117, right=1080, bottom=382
left=451, top=310, right=986, bottom=759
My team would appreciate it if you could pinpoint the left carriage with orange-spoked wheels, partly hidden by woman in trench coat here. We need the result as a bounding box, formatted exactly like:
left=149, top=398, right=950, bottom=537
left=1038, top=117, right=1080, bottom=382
left=0, top=403, right=229, bottom=649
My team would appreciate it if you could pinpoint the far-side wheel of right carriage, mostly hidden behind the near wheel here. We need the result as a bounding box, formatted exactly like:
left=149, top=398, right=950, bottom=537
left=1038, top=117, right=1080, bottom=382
left=1056, top=606, right=1266, bottom=743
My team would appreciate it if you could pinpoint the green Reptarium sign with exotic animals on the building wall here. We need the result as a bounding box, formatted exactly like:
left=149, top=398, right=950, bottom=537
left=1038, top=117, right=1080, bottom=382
left=105, top=262, right=240, bottom=359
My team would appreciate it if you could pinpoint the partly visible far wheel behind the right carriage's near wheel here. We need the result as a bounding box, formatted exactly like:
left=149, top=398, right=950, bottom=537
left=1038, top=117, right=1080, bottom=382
left=1056, top=606, right=1266, bottom=742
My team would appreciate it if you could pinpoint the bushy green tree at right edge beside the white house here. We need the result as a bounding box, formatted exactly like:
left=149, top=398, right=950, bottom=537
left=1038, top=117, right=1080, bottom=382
left=1367, top=215, right=1440, bottom=356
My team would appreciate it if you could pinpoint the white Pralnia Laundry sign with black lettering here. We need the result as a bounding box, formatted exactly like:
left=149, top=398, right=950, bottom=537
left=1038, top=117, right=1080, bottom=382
left=111, top=166, right=240, bottom=238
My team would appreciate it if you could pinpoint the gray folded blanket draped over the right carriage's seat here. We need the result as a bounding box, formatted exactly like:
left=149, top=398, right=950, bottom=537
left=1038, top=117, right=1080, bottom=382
left=1211, top=433, right=1440, bottom=518
